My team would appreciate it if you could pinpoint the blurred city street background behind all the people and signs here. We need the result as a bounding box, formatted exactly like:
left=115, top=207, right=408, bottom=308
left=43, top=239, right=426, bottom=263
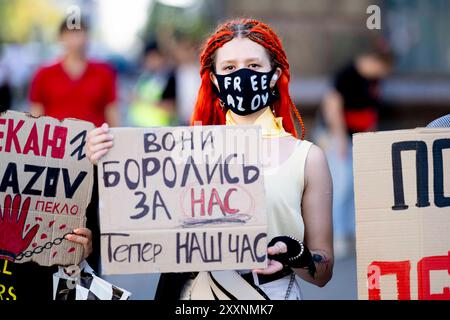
left=0, top=0, right=450, bottom=299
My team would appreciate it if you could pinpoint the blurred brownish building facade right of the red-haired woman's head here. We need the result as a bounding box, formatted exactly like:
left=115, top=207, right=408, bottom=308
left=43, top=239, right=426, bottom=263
left=223, top=0, right=450, bottom=130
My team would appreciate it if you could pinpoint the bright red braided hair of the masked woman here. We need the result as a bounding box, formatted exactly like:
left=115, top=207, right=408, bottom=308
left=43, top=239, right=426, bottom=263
left=191, top=19, right=305, bottom=139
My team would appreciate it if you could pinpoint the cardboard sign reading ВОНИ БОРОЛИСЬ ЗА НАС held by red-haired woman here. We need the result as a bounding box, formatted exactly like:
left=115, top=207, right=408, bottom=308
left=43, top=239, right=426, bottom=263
left=98, top=126, right=267, bottom=274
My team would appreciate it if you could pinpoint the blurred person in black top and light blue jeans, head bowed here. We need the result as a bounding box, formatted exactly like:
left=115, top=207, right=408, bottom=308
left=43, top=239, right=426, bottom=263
left=321, top=42, right=393, bottom=259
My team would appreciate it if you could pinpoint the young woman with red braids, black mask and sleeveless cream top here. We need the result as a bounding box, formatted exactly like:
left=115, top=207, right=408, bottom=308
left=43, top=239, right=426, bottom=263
left=87, top=19, right=333, bottom=299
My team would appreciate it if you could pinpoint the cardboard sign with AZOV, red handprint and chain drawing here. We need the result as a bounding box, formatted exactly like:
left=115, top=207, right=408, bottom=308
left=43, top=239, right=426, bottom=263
left=0, top=111, right=94, bottom=266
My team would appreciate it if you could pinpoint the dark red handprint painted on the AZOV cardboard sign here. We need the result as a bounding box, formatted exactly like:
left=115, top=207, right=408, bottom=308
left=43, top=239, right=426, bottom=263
left=0, top=194, right=39, bottom=261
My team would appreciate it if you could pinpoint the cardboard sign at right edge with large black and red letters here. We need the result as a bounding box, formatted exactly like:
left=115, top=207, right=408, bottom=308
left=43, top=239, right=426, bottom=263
left=353, top=128, right=450, bottom=300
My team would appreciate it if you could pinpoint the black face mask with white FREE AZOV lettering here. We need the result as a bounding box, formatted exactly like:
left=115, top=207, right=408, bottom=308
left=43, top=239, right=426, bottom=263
left=214, top=68, right=279, bottom=116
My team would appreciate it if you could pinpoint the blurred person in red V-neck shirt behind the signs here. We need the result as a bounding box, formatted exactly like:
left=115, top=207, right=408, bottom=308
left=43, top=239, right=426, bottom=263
left=29, top=20, right=119, bottom=126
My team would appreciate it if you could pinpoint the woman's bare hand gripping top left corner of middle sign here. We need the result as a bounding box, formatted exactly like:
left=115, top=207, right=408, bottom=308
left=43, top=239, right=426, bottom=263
left=86, top=123, right=114, bottom=164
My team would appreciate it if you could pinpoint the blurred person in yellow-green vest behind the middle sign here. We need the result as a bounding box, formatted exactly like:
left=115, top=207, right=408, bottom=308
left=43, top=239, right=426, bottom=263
left=129, top=41, right=177, bottom=127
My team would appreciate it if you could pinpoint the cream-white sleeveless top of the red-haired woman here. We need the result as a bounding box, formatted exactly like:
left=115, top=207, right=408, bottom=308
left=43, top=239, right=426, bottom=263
left=264, top=140, right=312, bottom=242
